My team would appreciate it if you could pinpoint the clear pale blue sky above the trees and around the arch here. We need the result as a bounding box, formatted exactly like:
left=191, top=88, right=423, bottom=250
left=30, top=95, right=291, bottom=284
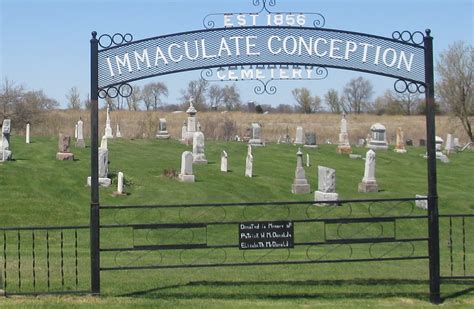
left=0, top=0, right=474, bottom=108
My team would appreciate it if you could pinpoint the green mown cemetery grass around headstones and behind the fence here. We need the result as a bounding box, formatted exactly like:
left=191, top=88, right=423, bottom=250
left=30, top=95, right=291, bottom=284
left=0, top=137, right=474, bottom=308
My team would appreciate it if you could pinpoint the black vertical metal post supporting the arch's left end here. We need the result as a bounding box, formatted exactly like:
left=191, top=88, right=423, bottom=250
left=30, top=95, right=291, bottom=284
left=90, top=31, right=100, bottom=295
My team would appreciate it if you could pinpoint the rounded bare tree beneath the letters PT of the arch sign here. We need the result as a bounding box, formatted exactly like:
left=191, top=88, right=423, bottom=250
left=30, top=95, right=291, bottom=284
left=344, top=76, right=373, bottom=114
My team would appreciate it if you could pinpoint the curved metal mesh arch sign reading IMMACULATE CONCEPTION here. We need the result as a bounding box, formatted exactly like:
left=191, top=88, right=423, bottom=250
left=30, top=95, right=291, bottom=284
left=98, top=26, right=425, bottom=95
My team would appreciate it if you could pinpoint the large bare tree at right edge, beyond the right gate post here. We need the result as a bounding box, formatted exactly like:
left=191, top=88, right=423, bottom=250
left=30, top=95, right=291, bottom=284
left=436, top=41, right=474, bottom=142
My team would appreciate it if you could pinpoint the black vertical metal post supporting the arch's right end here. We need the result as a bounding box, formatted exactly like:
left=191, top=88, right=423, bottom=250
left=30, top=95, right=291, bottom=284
left=423, top=29, right=441, bottom=304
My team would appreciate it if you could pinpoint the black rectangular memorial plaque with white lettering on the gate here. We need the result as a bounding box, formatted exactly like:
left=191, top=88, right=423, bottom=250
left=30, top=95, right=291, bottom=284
left=239, top=221, right=294, bottom=250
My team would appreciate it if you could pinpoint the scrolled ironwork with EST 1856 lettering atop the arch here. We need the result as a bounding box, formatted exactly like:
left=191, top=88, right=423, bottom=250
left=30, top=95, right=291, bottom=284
left=202, top=0, right=326, bottom=29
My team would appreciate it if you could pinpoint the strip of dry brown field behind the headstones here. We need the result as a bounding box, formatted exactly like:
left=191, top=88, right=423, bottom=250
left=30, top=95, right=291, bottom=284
left=21, top=110, right=468, bottom=145
